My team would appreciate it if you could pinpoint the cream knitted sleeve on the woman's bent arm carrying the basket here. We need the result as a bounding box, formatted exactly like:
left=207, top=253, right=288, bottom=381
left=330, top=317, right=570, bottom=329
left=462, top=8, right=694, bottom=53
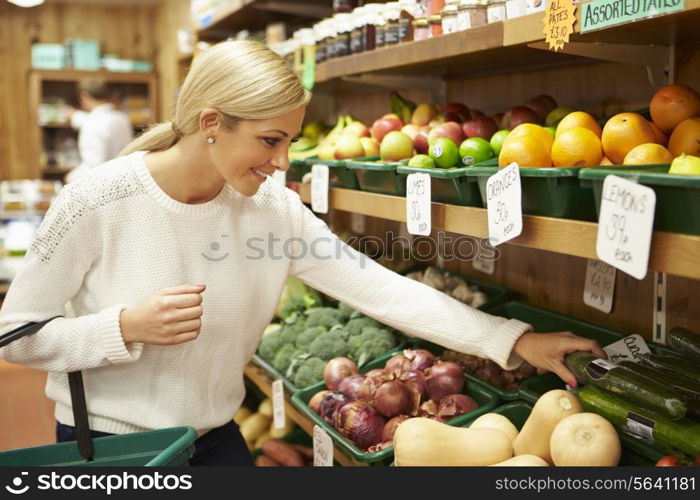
left=0, top=184, right=143, bottom=372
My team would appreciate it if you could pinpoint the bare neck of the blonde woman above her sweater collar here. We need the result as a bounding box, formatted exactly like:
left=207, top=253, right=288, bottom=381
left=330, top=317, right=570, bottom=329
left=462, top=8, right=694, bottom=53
left=144, top=136, right=225, bottom=205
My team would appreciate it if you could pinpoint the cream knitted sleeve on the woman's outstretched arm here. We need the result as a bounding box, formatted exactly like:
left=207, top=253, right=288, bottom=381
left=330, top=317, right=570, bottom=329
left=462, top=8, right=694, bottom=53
left=290, top=199, right=532, bottom=369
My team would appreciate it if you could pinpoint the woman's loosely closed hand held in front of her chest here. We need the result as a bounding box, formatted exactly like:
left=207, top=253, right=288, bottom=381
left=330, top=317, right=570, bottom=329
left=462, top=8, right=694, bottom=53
left=119, top=285, right=206, bottom=345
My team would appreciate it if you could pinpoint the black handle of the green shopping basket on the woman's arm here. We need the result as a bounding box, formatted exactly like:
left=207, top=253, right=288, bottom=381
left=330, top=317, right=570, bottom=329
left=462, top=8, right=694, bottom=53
left=0, top=316, right=94, bottom=462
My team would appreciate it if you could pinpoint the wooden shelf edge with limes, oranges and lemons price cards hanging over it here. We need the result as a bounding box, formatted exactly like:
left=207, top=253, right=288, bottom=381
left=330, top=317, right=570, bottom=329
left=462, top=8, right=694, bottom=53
left=299, top=184, right=700, bottom=279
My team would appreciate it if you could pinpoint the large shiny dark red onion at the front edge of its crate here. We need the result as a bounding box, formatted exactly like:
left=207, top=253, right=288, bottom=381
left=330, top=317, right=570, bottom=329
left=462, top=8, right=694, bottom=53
left=333, top=399, right=386, bottom=450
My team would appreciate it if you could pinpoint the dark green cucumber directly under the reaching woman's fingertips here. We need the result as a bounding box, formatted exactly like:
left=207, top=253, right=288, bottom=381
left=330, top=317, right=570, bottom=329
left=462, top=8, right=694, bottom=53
left=564, top=351, right=688, bottom=420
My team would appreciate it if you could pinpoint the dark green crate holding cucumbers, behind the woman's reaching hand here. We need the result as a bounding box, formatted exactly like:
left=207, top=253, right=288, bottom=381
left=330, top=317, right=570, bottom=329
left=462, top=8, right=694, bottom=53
left=487, top=301, right=669, bottom=403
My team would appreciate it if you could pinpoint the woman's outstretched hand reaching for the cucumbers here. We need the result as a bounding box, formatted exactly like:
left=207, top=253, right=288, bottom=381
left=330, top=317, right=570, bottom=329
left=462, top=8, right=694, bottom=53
left=513, top=332, right=607, bottom=388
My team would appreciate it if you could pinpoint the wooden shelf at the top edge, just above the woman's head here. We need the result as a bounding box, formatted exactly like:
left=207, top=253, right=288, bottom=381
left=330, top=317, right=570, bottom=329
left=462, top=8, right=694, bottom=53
left=196, top=0, right=332, bottom=40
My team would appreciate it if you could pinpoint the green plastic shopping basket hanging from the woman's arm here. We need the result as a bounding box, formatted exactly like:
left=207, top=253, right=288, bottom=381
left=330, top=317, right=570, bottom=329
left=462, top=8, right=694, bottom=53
left=0, top=426, right=197, bottom=467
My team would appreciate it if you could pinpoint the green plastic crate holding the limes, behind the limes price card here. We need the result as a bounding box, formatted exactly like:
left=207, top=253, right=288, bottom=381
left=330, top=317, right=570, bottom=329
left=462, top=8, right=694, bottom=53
left=396, top=166, right=481, bottom=207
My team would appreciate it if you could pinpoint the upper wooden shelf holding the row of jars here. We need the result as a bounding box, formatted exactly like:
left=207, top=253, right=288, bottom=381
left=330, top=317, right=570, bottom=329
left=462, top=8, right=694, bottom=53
left=316, top=0, right=700, bottom=83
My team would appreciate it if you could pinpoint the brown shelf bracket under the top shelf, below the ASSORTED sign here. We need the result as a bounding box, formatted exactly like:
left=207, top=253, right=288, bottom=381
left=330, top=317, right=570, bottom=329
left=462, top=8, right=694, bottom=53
left=528, top=42, right=676, bottom=88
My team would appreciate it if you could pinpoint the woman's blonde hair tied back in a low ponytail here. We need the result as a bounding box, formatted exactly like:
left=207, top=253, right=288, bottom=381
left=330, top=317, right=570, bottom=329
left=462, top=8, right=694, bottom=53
left=121, top=41, right=311, bottom=155
